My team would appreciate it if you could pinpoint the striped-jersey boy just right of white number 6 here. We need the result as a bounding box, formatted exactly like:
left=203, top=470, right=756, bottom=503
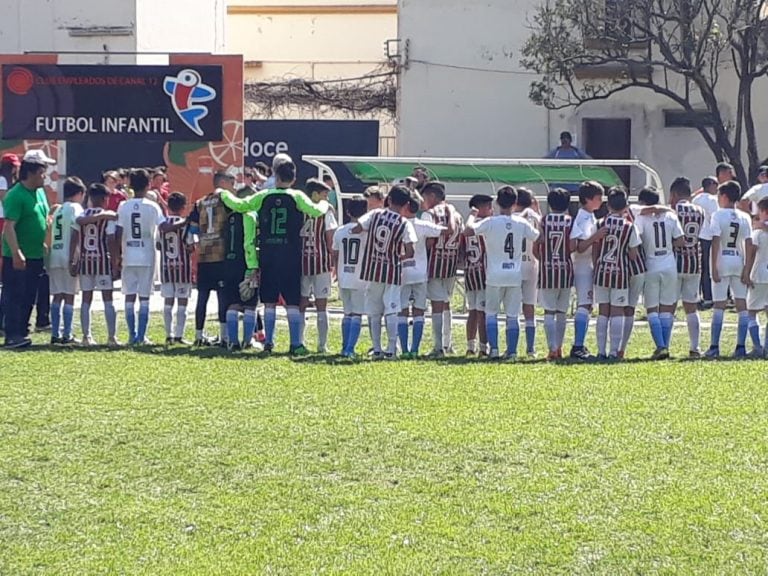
left=160, top=192, right=192, bottom=346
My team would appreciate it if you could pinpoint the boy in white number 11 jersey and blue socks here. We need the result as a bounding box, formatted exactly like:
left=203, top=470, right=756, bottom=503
left=635, top=187, right=685, bottom=360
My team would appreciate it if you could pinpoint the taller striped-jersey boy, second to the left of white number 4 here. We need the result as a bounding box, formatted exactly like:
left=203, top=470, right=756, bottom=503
left=421, top=181, right=464, bottom=357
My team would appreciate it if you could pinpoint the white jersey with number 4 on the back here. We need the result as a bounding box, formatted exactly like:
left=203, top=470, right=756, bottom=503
left=472, top=214, right=539, bottom=288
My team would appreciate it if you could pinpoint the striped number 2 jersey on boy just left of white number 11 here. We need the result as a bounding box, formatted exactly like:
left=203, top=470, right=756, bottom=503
left=595, top=214, right=640, bottom=289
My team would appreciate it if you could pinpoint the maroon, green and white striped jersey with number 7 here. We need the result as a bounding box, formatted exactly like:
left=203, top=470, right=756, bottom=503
left=539, top=213, right=573, bottom=290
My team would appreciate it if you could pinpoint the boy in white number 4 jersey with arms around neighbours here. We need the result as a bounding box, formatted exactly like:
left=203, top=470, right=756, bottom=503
left=465, top=186, right=539, bottom=361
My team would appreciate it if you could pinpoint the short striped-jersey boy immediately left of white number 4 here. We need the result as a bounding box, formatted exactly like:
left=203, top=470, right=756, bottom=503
left=462, top=194, right=493, bottom=356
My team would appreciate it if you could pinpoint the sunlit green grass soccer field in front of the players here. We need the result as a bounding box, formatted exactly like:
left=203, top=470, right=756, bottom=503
left=0, top=319, right=768, bottom=575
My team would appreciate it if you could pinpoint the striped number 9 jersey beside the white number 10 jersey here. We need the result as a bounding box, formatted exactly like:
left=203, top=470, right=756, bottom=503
left=358, top=208, right=418, bottom=286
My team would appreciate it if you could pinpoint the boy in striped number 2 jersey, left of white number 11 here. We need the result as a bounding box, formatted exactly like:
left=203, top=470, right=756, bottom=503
left=593, top=187, right=640, bottom=359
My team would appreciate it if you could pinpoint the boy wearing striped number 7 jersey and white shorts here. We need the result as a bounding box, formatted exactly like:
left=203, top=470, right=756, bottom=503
left=535, top=188, right=573, bottom=360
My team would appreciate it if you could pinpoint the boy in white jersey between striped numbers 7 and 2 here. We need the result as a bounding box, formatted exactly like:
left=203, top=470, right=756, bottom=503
left=571, top=181, right=605, bottom=360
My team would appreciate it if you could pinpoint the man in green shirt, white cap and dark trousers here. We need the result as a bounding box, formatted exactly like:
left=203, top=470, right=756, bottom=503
left=3, top=150, right=56, bottom=349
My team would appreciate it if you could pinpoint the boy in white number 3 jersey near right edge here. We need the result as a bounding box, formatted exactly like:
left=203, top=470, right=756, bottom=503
left=705, top=181, right=752, bottom=358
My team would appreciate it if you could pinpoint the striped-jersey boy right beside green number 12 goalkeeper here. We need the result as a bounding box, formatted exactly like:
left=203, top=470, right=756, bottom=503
left=300, top=178, right=338, bottom=354
